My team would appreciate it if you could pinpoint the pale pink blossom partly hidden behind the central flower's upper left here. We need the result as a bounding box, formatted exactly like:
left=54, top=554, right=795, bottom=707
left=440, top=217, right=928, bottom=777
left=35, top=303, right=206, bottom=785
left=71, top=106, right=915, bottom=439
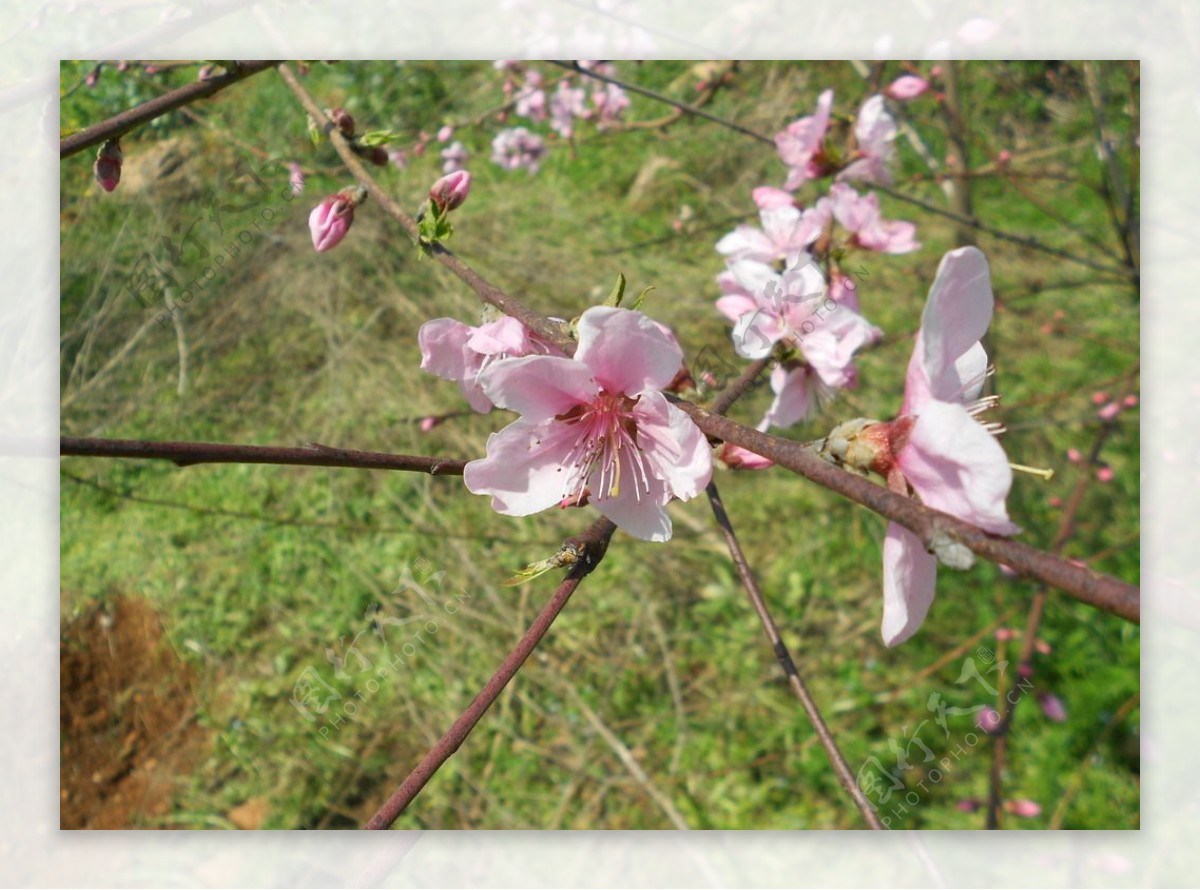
left=416, top=315, right=562, bottom=414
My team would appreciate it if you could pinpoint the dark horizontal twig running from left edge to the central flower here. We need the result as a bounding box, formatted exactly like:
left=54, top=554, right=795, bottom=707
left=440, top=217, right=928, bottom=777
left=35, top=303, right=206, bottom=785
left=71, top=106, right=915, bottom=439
left=59, top=435, right=467, bottom=476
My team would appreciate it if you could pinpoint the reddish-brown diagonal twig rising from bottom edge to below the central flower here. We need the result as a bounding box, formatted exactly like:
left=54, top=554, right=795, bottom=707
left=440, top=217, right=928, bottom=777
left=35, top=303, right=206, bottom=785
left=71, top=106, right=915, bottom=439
left=364, top=519, right=617, bottom=830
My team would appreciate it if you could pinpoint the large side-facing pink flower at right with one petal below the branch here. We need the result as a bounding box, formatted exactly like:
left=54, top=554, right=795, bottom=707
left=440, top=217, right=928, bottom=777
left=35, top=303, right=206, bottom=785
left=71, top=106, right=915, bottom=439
left=878, top=247, right=1019, bottom=645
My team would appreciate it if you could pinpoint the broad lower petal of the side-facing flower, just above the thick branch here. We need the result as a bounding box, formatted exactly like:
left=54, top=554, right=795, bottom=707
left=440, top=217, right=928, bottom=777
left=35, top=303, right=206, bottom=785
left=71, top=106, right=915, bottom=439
left=899, top=402, right=1020, bottom=535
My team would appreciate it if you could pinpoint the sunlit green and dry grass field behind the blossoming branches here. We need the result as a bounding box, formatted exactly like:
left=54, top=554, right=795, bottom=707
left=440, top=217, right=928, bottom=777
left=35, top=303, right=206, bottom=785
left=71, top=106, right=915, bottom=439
left=61, top=62, right=1140, bottom=829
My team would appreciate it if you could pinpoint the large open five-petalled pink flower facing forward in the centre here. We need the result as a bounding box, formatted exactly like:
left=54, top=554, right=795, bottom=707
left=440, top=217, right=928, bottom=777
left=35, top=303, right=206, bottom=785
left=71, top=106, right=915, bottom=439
left=463, top=306, right=713, bottom=541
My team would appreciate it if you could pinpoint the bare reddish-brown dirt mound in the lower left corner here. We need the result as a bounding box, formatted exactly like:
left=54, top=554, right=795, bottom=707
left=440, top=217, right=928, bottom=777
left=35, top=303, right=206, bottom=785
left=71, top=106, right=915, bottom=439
left=59, top=597, right=205, bottom=829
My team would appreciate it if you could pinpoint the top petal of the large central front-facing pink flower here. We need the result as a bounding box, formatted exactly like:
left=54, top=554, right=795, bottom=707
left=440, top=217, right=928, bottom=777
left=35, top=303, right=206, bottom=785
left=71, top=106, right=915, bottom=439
left=575, top=306, right=683, bottom=396
